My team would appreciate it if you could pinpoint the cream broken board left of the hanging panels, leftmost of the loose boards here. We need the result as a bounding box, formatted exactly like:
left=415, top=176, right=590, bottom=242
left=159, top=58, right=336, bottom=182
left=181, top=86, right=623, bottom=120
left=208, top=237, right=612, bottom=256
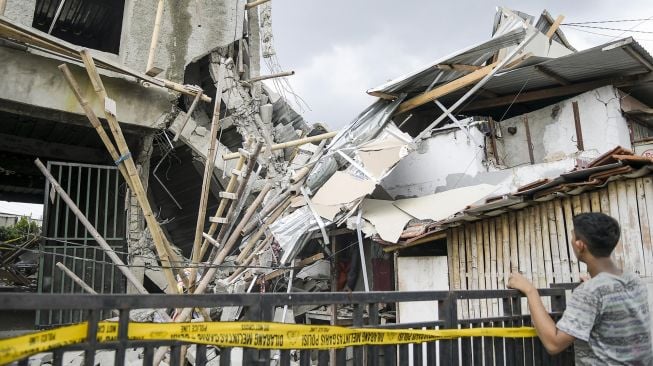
left=313, top=171, right=376, bottom=206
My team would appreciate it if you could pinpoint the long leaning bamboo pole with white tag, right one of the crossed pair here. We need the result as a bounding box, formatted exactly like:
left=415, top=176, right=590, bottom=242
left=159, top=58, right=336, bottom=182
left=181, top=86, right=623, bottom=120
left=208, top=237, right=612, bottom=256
left=80, top=50, right=178, bottom=292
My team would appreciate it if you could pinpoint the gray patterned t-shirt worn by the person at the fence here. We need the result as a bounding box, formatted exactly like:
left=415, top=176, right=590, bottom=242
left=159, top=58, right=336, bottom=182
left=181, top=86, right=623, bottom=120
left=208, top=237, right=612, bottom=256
left=557, top=272, right=653, bottom=365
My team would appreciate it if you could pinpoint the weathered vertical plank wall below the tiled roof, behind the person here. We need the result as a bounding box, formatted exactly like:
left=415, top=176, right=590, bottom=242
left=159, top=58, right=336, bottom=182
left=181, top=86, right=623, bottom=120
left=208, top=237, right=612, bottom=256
left=447, top=176, right=653, bottom=318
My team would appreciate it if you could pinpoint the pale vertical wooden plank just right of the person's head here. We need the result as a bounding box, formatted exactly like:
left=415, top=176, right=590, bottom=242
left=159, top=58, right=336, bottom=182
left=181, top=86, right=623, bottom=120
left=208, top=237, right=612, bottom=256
left=617, top=179, right=646, bottom=276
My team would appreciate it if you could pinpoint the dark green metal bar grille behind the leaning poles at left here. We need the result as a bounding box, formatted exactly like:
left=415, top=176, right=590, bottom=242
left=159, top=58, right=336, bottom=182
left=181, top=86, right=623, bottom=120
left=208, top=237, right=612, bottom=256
left=36, top=162, right=127, bottom=327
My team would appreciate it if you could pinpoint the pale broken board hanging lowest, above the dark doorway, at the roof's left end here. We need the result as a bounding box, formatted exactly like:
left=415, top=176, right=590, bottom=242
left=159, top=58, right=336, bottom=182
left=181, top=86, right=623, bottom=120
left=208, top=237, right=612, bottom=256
left=362, top=199, right=413, bottom=243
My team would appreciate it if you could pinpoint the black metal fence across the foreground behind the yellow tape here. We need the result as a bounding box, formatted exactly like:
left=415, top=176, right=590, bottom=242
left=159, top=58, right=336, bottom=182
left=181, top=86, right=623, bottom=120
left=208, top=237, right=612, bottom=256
left=0, top=288, right=574, bottom=365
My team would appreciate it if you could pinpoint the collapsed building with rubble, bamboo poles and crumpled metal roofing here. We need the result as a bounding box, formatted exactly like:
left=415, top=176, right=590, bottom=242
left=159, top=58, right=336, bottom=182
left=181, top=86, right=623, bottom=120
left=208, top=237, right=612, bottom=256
left=0, top=0, right=653, bottom=364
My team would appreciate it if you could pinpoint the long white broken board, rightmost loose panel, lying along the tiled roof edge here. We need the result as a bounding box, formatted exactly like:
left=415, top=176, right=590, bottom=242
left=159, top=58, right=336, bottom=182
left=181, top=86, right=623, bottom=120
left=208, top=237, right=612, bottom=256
left=394, top=184, right=497, bottom=222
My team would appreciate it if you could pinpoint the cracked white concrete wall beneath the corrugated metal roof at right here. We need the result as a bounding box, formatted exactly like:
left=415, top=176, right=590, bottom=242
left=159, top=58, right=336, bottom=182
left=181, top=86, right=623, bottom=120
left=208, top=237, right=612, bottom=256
left=382, top=86, right=632, bottom=198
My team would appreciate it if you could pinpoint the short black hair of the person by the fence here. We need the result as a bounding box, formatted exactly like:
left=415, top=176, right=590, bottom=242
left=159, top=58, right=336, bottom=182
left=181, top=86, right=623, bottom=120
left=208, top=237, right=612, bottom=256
left=574, top=212, right=621, bottom=257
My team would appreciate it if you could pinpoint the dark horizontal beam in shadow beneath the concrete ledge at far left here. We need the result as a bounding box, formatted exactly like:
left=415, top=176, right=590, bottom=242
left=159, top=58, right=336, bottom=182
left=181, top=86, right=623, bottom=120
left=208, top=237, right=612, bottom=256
left=0, top=134, right=111, bottom=164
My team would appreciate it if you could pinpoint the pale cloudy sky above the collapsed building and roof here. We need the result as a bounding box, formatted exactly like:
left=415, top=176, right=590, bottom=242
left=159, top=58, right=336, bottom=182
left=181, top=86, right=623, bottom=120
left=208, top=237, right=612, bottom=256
left=263, top=0, right=653, bottom=129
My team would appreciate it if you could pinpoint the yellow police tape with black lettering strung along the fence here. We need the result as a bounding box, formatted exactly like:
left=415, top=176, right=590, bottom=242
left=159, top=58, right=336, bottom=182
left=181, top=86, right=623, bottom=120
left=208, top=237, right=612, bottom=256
left=0, top=321, right=536, bottom=364
